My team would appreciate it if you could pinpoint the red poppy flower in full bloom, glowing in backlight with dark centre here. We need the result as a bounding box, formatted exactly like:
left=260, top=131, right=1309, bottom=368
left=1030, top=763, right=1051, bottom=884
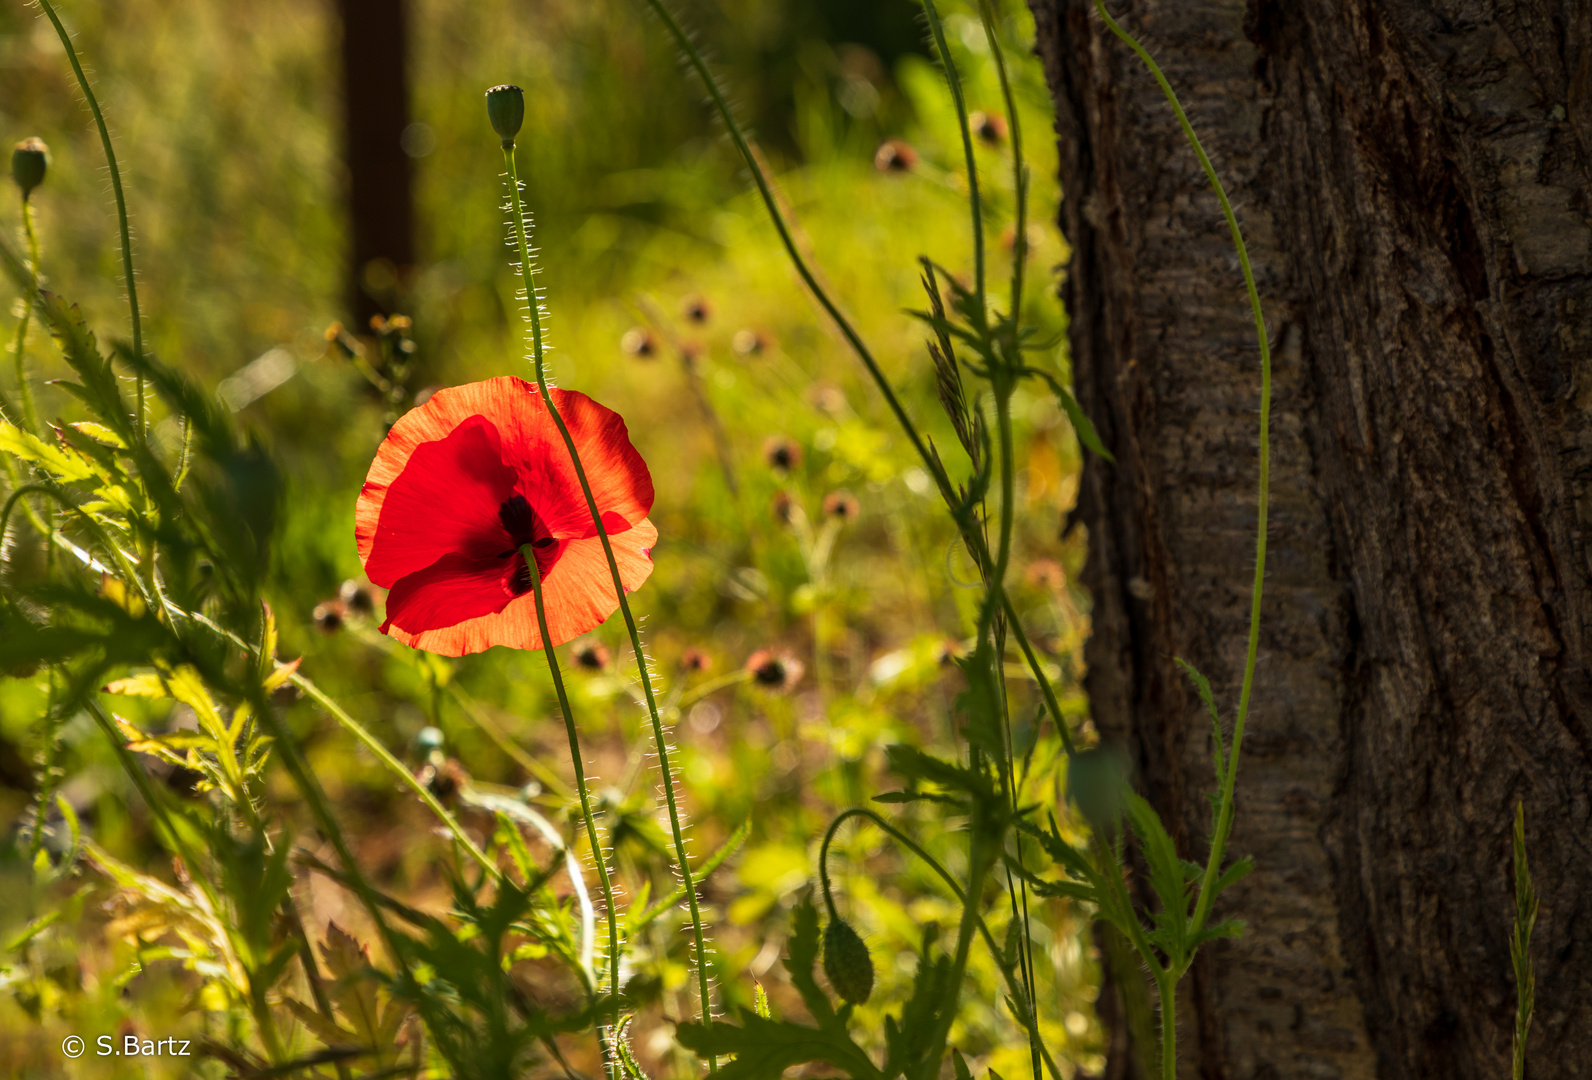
left=355, top=378, right=657, bottom=656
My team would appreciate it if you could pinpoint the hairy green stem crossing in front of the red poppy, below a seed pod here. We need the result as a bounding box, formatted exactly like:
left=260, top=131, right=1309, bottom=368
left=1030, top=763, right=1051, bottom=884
left=503, top=139, right=718, bottom=1072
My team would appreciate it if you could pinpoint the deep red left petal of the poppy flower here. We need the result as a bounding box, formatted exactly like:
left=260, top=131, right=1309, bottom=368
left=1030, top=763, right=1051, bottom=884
left=355, top=409, right=519, bottom=586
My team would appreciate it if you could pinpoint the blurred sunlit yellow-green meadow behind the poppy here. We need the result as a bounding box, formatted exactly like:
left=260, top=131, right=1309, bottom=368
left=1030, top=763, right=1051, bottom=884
left=0, top=0, right=1100, bottom=1077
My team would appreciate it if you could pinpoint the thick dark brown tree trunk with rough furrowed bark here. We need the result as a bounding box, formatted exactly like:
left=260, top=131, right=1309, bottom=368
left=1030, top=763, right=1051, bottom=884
left=1032, top=0, right=1592, bottom=1080
